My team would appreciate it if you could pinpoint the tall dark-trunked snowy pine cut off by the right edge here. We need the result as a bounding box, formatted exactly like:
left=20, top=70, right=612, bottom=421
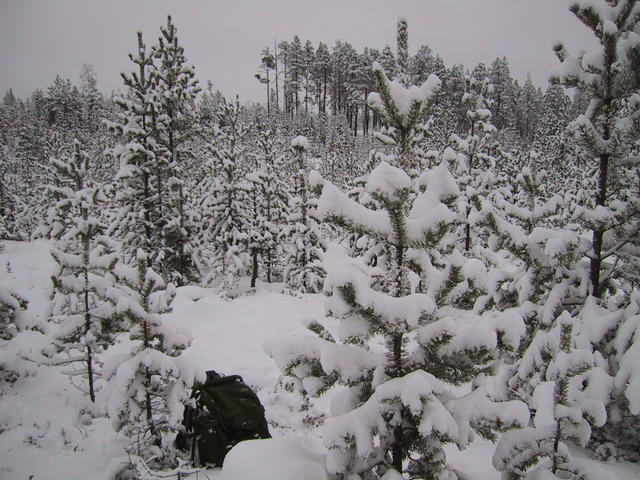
left=551, top=0, right=640, bottom=298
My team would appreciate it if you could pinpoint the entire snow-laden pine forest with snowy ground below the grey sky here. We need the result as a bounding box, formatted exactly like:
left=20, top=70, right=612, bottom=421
left=0, top=0, right=640, bottom=480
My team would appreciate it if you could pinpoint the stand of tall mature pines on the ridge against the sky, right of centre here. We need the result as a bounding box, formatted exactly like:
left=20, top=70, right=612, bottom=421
left=256, top=35, right=587, bottom=144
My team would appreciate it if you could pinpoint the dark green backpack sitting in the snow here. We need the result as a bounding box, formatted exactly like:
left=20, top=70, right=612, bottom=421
left=176, top=371, right=271, bottom=466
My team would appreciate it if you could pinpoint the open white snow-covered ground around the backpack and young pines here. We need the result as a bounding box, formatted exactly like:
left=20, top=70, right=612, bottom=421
left=0, top=241, right=640, bottom=480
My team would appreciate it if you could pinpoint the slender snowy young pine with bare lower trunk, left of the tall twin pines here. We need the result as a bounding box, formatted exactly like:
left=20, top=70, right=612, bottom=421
left=48, top=141, right=121, bottom=402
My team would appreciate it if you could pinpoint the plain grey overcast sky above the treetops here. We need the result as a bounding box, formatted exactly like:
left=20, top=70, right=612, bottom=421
left=0, top=0, right=594, bottom=100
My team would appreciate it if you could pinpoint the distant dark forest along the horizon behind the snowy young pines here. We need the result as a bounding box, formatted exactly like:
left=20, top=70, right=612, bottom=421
left=0, top=22, right=588, bottom=248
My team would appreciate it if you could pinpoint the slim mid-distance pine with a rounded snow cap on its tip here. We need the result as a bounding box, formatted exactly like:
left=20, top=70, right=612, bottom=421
left=280, top=135, right=325, bottom=293
